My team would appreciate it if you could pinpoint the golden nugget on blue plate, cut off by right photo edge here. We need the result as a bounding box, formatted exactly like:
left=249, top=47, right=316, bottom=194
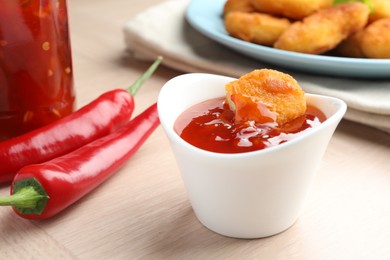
left=361, top=18, right=390, bottom=59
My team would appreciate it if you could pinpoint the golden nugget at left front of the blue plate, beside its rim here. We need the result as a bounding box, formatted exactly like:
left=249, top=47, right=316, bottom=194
left=225, top=11, right=290, bottom=46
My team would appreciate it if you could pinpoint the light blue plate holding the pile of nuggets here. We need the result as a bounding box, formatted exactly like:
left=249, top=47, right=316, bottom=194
left=186, top=0, right=390, bottom=78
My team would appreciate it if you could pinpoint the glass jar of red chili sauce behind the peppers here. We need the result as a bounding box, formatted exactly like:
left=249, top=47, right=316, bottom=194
left=0, top=0, right=75, bottom=141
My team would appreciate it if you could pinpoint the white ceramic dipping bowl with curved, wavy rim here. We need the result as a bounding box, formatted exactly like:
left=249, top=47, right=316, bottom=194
left=158, top=73, right=346, bottom=238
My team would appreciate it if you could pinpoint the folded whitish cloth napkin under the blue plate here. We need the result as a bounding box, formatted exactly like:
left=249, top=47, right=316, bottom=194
left=124, top=0, right=390, bottom=132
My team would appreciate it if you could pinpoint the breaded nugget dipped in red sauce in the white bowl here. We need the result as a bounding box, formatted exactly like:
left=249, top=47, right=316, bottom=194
left=225, top=69, right=306, bottom=125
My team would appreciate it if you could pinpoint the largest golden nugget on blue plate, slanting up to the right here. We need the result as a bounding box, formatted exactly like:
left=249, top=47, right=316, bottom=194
left=274, top=2, right=370, bottom=54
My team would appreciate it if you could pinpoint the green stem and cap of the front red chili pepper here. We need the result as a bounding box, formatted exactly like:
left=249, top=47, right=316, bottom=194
left=0, top=186, right=49, bottom=209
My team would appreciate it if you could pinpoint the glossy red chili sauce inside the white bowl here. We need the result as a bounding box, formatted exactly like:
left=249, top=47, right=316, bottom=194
left=174, top=97, right=326, bottom=153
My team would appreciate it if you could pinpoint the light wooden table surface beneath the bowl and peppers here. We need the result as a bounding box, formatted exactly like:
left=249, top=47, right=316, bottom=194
left=0, top=0, right=390, bottom=260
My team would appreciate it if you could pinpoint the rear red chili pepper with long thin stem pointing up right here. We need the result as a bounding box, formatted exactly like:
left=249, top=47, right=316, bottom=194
left=0, top=57, right=162, bottom=183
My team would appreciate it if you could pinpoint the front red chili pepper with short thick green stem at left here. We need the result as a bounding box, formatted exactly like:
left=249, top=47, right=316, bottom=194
left=0, top=103, right=160, bottom=219
